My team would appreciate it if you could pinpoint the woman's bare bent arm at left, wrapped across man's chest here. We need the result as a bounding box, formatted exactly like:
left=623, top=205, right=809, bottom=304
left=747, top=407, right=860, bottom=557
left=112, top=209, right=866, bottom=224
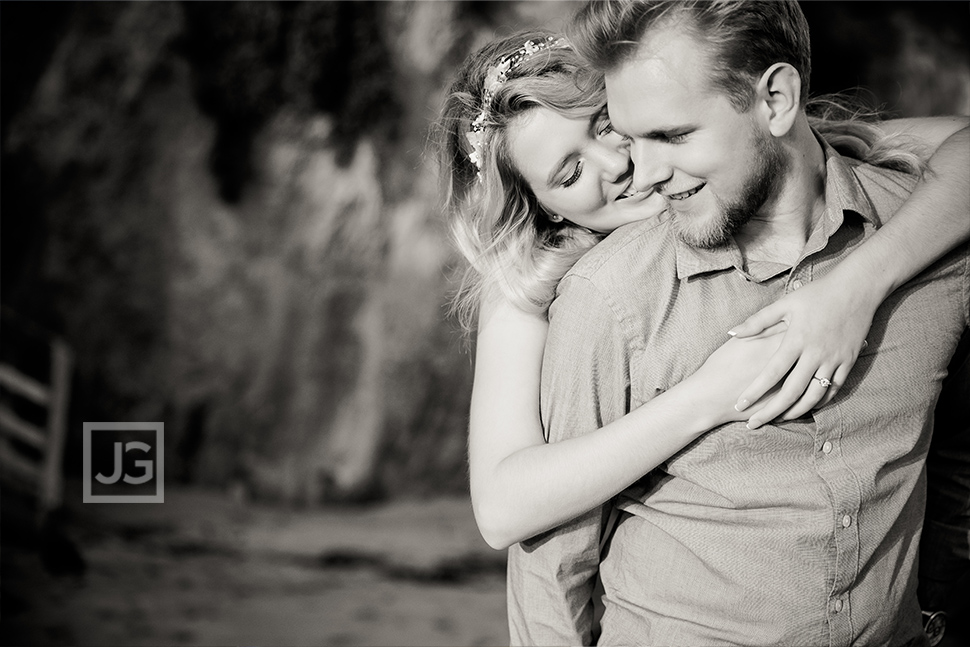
left=469, top=302, right=781, bottom=548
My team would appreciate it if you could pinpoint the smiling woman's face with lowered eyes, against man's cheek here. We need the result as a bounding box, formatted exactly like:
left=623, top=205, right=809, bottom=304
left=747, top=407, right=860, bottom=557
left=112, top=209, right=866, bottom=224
left=508, top=108, right=666, bottom=233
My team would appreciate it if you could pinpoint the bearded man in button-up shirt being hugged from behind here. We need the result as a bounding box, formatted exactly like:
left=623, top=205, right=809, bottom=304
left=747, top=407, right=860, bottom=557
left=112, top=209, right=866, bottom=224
left=509, top=1, right=970, bottom=645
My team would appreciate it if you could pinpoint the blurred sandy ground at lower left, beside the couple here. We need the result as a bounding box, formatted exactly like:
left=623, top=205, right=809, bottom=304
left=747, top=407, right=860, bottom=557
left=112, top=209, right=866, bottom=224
left=0, top=491, right=508, bottom=646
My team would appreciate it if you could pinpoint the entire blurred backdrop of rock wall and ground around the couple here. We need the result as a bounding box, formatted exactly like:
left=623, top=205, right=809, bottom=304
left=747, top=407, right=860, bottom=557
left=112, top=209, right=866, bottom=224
left=0, top=0, right=970, bottom=645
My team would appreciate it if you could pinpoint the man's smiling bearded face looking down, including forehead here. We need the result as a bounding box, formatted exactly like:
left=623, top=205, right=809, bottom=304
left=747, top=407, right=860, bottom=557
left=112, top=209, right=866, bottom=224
left=606, top=27, right=785, bottom=248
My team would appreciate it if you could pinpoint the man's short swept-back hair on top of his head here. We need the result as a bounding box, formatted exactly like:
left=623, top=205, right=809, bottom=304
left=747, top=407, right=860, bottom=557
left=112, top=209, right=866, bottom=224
left=570, top=0, right=812, bottom=112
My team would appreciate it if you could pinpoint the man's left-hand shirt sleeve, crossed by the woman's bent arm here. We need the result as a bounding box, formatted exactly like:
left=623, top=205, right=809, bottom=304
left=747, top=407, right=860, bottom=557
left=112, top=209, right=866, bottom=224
left=508, top=276, right=630, bottom=645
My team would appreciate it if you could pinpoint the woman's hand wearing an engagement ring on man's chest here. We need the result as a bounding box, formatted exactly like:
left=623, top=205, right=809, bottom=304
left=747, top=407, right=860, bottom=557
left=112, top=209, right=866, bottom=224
left=729, top=275, right=882, bottom=429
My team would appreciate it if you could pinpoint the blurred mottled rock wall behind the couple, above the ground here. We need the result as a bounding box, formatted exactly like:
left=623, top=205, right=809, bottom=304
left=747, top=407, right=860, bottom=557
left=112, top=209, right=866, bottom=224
left=0, top=1, right=970, bottom=503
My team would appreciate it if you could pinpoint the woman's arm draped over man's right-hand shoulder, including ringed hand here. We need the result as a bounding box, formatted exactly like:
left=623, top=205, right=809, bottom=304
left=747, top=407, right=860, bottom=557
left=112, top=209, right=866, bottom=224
left=729, top=117, right=970, bottom=429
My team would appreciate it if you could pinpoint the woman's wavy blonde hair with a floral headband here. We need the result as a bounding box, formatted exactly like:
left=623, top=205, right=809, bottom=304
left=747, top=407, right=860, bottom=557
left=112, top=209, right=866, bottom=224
left=433, top=31, right=925, bottom=331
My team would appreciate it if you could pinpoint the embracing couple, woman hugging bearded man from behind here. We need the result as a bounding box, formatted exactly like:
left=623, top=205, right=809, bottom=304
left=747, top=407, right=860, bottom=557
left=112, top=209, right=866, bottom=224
left=439, top=0, right=970, bottom=645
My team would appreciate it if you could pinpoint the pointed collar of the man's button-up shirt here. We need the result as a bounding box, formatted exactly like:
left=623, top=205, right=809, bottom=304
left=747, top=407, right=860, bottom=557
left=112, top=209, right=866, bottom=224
left=674, top=129, right=880, bottom=280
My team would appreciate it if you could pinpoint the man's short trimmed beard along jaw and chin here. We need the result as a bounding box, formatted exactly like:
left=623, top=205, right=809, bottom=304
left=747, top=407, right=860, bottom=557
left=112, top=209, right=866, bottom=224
left=673, top=135, right=788, bottom=249
